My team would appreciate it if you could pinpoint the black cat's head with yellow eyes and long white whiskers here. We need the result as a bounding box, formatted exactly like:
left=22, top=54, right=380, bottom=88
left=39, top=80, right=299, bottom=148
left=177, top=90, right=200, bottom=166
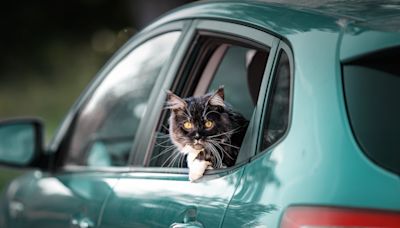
left=166, top=87, right=232, bottom=151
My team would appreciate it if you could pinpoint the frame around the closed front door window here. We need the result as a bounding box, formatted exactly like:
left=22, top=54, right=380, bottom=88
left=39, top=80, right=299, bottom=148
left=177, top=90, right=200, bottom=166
left=47, top=20, right=191, bottom=171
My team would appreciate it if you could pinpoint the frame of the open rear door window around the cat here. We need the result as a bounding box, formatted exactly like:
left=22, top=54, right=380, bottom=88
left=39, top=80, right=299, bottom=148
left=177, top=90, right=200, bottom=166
left=138, top=20, right=280, bottom=174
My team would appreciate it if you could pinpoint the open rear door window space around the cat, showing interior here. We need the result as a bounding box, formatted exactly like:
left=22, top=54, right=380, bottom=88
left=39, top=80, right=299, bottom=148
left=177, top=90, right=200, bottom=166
left=146, top=33, right=271, bottom=168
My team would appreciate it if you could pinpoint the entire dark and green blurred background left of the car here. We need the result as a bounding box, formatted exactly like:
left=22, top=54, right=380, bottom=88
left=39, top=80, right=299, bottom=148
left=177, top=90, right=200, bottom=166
left=0, top=0, right=191, bottom=189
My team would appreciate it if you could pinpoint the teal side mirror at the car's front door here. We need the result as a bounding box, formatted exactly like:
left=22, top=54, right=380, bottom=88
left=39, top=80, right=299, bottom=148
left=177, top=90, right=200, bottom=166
left=0, top=118, right=43, bottom=167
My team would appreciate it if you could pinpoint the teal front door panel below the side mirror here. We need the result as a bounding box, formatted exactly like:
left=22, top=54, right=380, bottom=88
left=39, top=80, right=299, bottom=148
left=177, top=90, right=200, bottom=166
left=1, top=171, right=116, bottom=228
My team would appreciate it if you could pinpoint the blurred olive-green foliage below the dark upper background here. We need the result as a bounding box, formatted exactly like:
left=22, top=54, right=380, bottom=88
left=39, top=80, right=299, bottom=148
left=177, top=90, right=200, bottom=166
left=0, top=40, right=108, bottom=189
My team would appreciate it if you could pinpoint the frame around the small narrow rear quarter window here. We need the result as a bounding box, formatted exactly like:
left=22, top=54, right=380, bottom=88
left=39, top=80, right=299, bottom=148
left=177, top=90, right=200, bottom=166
left=252, top=41, right=294, bottom=157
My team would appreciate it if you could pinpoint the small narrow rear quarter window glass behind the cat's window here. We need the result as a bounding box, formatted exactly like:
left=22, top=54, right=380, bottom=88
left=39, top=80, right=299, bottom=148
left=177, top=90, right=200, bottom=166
left=260, top=50, right=290, bottom=151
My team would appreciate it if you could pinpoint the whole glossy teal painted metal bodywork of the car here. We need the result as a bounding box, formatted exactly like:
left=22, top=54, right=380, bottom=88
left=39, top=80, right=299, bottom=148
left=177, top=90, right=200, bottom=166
left=3, top=1, right=400, bottom=227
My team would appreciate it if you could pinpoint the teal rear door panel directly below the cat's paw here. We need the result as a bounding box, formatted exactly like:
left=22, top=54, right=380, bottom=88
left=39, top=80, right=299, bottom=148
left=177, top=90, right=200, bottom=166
left=100, top=168, right=243, bottom=227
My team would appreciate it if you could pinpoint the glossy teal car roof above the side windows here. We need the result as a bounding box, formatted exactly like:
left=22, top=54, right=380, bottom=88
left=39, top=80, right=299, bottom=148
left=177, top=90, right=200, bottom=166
left=146, top=0, right=400, bottom=32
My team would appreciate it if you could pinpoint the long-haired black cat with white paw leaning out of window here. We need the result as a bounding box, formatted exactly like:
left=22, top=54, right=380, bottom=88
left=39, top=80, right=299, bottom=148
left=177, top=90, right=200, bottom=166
left=166, top=87, right=248, bottom=181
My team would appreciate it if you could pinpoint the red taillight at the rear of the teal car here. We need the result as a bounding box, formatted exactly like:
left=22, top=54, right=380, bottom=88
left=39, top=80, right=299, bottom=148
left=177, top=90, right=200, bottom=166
left=281, top=206, right=400, bottom=228
